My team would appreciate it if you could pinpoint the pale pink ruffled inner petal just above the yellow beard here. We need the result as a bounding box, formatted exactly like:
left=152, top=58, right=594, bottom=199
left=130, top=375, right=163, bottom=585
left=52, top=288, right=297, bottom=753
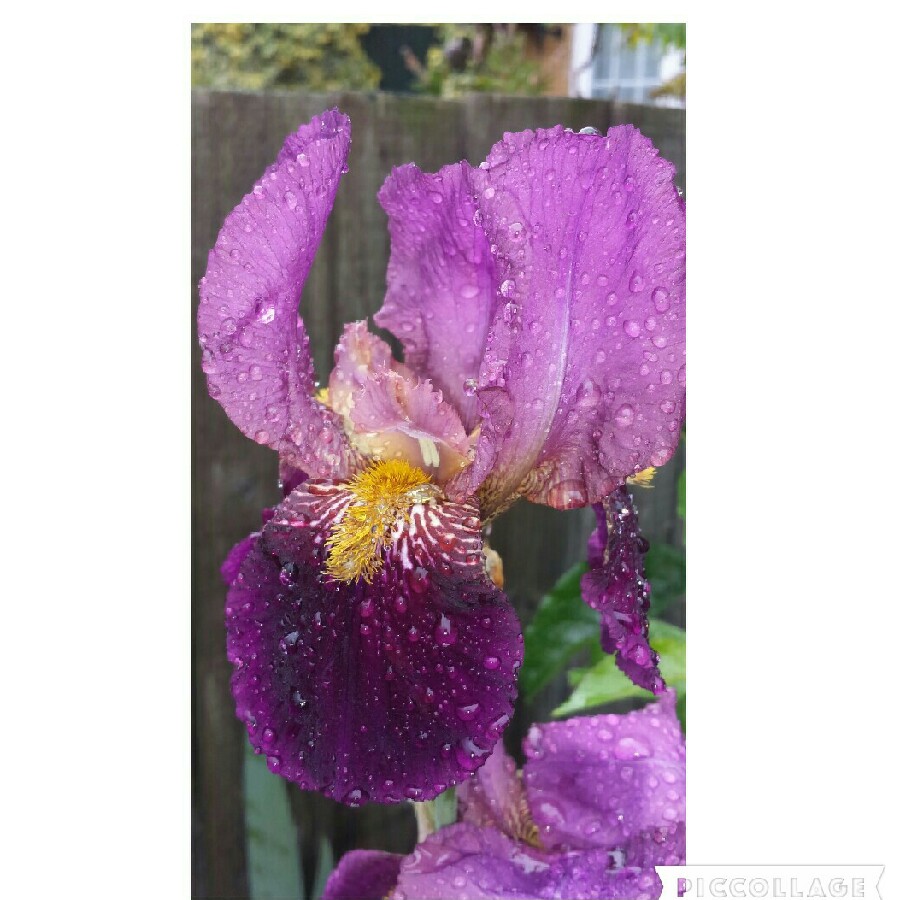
left=350, top=372, right=469, bottom=484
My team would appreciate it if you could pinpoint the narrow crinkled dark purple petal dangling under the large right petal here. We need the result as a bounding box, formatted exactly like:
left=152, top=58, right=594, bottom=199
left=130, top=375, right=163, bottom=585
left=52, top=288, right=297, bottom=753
left=581, top=487, right=666, bottom=694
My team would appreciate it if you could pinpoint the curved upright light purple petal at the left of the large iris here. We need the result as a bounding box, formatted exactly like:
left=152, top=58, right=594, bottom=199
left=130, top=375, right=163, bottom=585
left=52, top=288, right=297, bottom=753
left=197, top=109, right=356, bottom=478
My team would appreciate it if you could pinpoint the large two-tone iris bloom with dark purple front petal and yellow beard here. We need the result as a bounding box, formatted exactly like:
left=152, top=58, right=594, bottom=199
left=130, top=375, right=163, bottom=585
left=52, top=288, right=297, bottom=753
left=198, top=110, right=684, bottom=804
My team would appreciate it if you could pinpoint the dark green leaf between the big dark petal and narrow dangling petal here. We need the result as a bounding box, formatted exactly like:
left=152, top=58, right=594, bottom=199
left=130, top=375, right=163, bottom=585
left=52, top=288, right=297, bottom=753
left=519, top=562, right=600, bottom=699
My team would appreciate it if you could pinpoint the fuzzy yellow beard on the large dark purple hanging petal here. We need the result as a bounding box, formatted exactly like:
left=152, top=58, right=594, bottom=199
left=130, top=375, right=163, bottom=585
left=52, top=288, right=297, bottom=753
left=325, top=459, right=441, bottom=582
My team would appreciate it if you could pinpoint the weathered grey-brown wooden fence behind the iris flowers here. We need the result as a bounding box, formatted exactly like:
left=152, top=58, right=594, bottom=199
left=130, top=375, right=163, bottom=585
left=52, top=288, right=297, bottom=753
left=190, top=91, right=685, bottom=900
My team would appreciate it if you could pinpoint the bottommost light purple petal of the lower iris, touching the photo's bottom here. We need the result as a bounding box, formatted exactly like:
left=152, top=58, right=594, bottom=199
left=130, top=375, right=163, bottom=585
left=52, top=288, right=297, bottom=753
left=391, top=823, right=661, bottom=900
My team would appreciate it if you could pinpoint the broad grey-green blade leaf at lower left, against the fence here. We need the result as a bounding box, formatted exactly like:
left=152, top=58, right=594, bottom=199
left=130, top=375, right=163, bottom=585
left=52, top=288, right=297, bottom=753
left=244, top=741, right=303, bottom=900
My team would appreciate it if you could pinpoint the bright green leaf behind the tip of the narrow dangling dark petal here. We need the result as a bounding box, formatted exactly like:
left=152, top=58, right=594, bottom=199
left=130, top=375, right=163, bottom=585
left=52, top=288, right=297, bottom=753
left=552, top=619, right=685, bottom=718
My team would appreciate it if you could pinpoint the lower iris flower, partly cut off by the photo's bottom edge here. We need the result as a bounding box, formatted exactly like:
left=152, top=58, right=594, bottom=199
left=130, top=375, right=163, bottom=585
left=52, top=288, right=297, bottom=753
left=323, top=692, right=685, bottom=900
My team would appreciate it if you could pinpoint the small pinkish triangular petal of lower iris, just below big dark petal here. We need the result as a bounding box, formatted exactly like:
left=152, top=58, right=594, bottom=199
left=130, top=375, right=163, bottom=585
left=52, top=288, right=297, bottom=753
left=456, top=741, right=536, bottom=841
